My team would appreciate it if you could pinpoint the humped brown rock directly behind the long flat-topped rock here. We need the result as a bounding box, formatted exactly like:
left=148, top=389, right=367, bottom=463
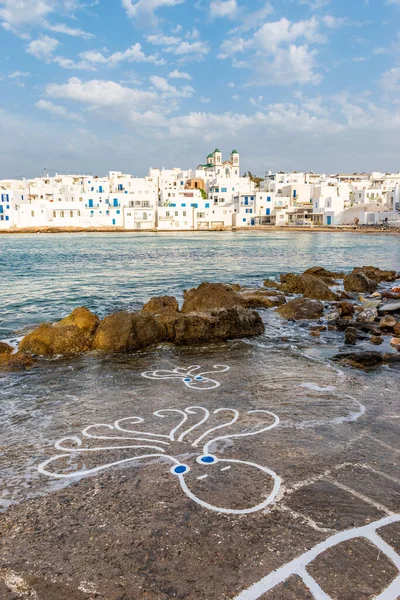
left=181, top=283, right=246, bottom=313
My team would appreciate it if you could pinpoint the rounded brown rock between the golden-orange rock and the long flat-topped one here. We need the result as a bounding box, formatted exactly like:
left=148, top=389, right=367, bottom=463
left=93, top=312, right=167, bottom=352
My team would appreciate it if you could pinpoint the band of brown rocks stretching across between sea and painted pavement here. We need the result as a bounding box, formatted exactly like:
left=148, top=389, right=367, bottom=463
left=0, top=266, right=400, bottom=371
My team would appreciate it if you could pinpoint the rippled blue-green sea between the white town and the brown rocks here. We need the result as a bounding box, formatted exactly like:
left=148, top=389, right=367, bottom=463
left=0, top=232, right=400, bottom=339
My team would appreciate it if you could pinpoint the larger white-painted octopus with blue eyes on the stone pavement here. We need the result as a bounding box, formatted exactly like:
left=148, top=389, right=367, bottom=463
left=38, top=406, right=281, bottom=515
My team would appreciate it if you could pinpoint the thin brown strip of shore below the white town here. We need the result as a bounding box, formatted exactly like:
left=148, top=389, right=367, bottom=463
left=0, top=225, right=400, bottom=235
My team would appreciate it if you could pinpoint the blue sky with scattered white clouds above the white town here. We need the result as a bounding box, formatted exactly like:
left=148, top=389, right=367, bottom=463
left=0, top=0, right=400, bottom=177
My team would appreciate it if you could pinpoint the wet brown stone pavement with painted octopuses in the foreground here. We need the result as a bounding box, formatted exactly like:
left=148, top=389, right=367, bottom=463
left=0, top=338, right=400, bottom=600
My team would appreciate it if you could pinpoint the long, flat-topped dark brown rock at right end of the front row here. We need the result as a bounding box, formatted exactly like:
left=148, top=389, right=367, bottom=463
left=174, top=307, right=265, bottom=345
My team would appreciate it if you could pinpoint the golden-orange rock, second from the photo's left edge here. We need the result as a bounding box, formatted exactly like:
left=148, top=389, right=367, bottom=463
left=19, top=323, right=92, bottom=356
